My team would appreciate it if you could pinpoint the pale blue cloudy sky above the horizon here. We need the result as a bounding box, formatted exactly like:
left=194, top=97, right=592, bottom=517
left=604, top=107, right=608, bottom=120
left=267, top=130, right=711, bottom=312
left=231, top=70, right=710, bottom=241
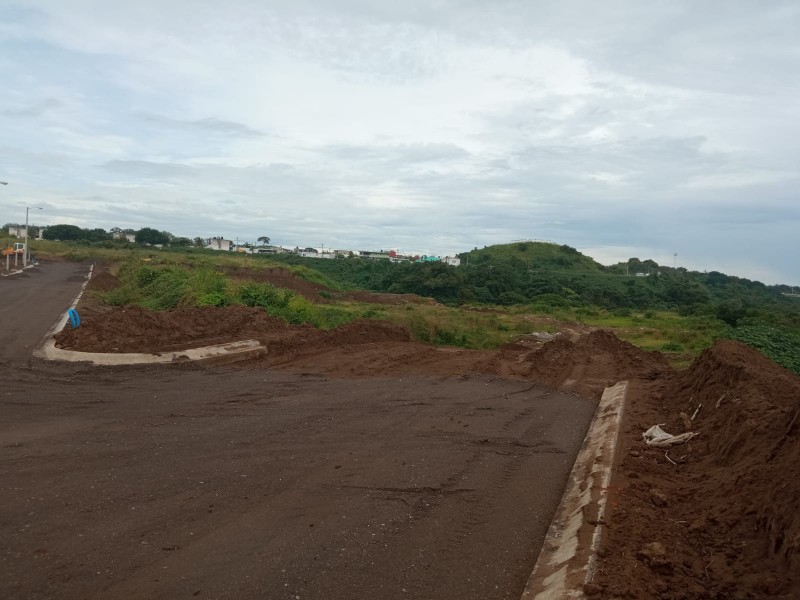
left=0, top=0, right=800, bottom=285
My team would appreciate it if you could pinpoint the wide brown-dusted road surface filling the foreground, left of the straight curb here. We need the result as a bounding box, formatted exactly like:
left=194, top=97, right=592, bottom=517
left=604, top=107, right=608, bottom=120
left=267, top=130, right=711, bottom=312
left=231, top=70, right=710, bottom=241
left=0, top=265, right=595, bottom=599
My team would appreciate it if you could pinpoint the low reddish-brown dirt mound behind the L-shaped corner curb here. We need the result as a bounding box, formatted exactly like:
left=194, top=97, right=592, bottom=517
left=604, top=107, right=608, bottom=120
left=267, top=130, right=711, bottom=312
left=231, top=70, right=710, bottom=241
left=56, top=306, right=287, bottom=353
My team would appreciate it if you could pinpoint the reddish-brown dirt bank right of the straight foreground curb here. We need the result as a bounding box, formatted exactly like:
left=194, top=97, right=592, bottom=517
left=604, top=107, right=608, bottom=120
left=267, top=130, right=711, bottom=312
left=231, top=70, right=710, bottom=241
left=596, top=341, right=800, bottom=598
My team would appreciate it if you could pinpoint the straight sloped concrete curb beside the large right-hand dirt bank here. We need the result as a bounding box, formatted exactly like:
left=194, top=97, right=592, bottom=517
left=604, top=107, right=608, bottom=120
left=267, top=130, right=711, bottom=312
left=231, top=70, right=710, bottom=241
left=521, top=381, right=628, bottom=600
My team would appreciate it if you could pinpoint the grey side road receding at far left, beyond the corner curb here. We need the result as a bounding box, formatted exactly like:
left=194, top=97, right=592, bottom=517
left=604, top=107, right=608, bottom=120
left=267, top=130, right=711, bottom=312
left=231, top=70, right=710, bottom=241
left=0, top=262, right=89, bottom=361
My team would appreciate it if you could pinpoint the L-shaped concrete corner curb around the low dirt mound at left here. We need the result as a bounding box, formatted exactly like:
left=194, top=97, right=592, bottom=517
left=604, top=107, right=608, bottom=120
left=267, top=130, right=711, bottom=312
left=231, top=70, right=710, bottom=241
left=33, top=265, right=267, bottom=365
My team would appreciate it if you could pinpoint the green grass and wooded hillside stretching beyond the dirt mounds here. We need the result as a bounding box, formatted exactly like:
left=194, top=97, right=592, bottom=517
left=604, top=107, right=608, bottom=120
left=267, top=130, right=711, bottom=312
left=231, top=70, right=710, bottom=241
left=37, top=241, right=800, bottom=372
